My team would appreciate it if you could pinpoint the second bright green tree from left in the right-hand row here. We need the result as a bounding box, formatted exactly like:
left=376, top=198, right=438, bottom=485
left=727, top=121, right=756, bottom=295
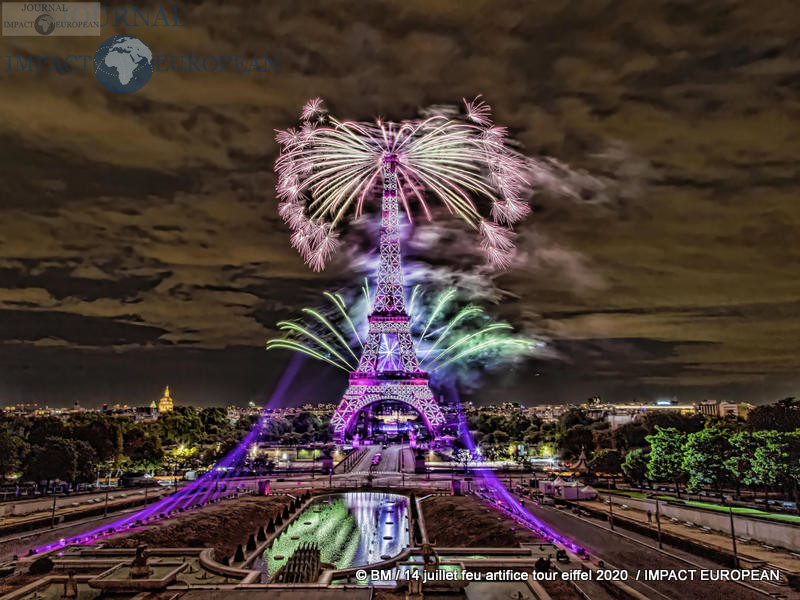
left=681, top=426, right=733, bottom=491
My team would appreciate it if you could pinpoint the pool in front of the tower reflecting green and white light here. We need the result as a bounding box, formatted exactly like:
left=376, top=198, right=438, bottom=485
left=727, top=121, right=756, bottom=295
left=262, top=492, right=409, bottom=580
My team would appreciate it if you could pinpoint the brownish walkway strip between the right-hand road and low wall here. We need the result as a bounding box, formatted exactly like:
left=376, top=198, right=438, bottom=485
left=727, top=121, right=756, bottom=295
left=580, top=500, right=800, bottom=572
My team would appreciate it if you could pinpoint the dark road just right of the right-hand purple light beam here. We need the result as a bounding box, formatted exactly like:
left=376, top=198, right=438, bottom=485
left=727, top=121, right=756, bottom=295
left=525, top=500, right=788, bottom=600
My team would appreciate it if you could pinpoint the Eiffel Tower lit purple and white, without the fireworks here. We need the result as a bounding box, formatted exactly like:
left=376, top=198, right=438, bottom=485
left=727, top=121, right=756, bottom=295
left=331, top=154, right=444, bottom=443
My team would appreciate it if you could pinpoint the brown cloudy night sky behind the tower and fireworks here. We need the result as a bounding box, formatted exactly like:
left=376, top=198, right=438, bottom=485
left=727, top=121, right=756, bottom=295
left=0, top=0, right=800, bottom=406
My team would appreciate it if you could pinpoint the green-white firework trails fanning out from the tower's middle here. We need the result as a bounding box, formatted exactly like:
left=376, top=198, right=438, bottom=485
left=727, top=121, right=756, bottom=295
left=267, top=281, right=543, bottom=379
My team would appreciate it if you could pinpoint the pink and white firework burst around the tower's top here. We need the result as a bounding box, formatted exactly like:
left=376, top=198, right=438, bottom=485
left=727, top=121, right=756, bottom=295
left=275, top=96, right=531, bottom=270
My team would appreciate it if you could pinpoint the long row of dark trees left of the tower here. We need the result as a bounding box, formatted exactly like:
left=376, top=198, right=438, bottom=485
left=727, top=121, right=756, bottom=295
left=0, top=406, right=330, bottom=483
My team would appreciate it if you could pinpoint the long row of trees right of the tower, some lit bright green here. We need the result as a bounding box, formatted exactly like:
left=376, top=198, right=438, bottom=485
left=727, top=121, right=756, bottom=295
left=469, top=398, right=800, bottom=496
